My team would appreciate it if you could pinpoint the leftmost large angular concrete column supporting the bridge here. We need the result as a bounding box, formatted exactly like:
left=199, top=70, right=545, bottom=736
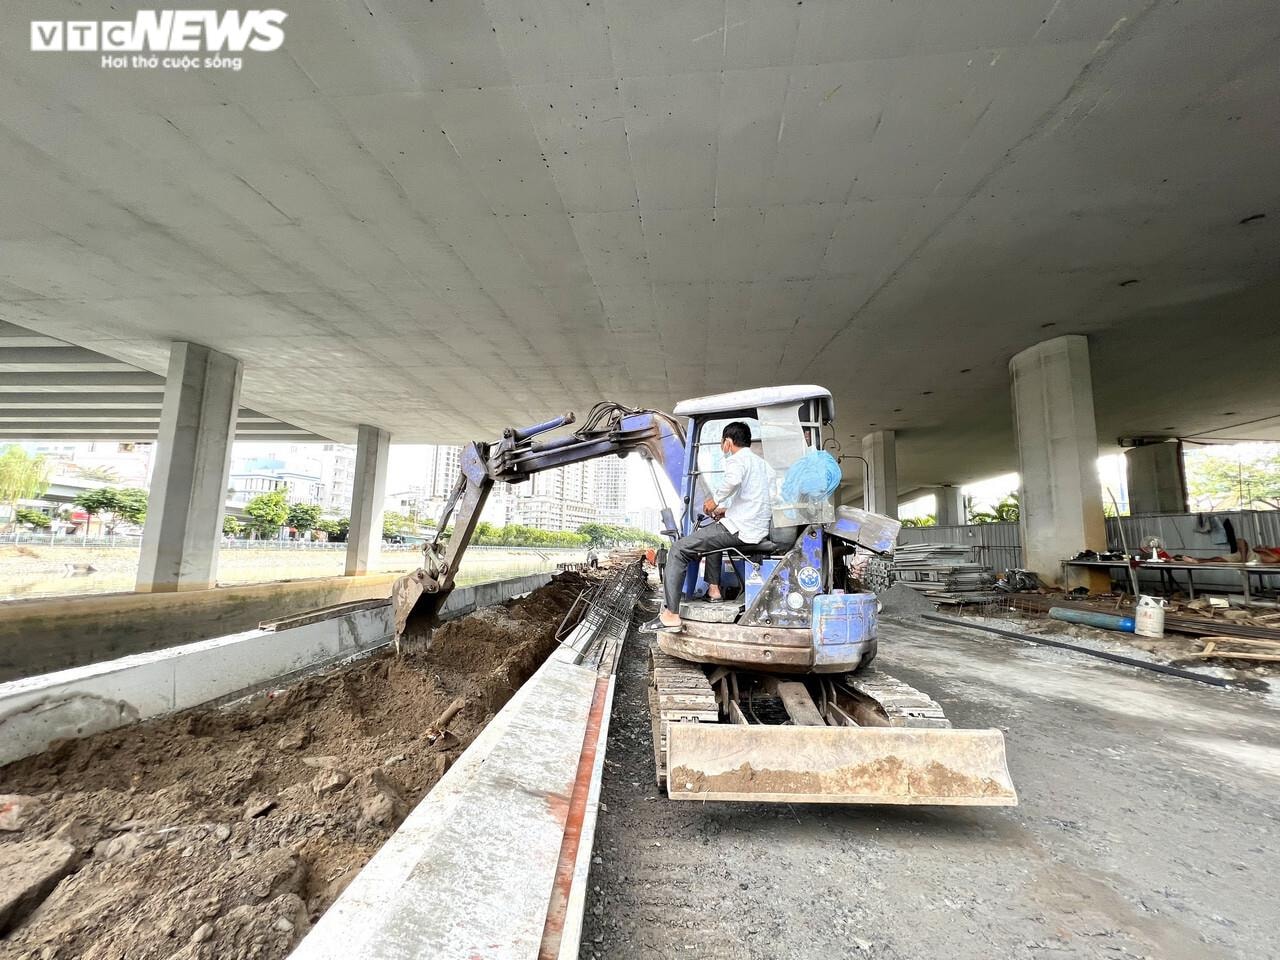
left=137, top=343, right=241, bottom=593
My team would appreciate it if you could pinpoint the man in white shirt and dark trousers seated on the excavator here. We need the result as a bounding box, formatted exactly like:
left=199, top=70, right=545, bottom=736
left=644, top=420, right=773, bottom=634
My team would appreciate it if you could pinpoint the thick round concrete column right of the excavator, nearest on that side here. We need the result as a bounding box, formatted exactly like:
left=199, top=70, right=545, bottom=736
left=1009, top=335, right=1110, bottom=591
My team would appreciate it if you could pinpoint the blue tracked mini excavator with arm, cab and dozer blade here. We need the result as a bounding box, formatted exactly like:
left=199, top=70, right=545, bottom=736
left=392, top=385, right=1018, bottom=806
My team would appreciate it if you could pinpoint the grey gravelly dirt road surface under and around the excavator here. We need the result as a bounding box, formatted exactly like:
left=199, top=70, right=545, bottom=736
left=581, top=618, right=1280, bottom=960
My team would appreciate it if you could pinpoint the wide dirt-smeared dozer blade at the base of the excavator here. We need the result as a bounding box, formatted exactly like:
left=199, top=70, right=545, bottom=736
left=667, top=723, right=1018, bottom=806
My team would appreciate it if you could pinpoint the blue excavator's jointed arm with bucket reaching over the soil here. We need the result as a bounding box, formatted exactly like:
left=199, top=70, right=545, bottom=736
left=392, top=401, right=685, bottom=643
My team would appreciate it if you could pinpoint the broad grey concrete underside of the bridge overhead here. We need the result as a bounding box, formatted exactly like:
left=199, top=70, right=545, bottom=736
left=0, top=0, right=1280, bottom=489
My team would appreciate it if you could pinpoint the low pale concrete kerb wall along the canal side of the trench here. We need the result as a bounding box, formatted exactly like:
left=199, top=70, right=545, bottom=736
left=0, top=573, right=550, bottom=764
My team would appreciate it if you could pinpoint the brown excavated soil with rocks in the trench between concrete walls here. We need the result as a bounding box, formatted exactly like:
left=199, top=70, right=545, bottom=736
left=0, top=573, right=586, bottom=960
